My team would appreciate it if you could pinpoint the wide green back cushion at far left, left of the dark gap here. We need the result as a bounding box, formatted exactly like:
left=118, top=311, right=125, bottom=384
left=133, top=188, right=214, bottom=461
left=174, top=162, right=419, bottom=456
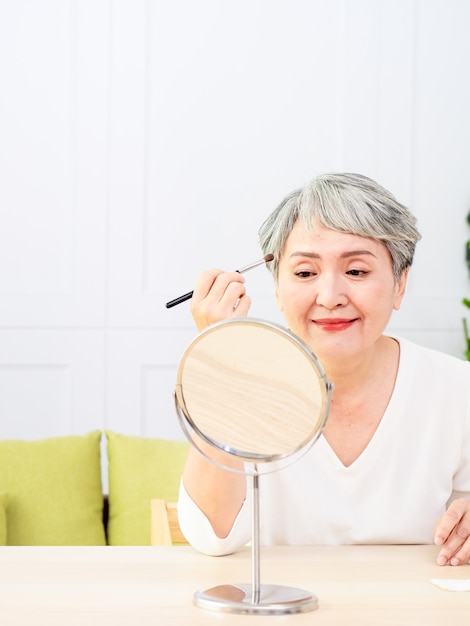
left=0, top=431, right=106, bottom=546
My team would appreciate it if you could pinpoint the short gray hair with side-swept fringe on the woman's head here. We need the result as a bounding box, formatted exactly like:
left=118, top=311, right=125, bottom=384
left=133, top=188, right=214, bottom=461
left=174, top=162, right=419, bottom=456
left=258, top=173, right=421, bottom=280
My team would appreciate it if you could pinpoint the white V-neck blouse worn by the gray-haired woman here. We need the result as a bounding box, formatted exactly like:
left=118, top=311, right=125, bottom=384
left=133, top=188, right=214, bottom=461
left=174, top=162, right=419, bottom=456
left=178, top=339, right=470, bottom=555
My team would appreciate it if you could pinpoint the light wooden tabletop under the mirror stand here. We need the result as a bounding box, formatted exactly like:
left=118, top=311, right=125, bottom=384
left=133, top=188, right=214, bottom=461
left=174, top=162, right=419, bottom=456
left=0, top=546, right=470, bottom=626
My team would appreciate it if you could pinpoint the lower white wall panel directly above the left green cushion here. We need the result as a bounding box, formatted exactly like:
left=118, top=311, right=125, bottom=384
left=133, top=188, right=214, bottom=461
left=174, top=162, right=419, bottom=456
left=0, top=330, right=105, bottom=439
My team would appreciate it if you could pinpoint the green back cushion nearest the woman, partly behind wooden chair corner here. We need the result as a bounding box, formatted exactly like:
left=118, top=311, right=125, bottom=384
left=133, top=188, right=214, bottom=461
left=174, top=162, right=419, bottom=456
left=106, top=430, right=189, bottom=546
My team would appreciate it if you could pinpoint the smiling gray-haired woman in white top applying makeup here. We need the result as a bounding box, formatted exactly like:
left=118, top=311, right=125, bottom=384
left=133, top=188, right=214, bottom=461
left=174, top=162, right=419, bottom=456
left=179, top=174, right=470, bottom=565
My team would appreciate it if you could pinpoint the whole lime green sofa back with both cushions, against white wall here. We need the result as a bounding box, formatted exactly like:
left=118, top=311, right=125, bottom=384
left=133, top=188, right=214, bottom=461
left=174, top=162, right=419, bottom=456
left=0, top=430, right=189, bottom=546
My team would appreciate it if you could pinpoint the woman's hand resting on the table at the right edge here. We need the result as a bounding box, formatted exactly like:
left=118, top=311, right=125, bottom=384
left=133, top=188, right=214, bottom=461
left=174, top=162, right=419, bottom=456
left=434, top=498, right=470, bottom=565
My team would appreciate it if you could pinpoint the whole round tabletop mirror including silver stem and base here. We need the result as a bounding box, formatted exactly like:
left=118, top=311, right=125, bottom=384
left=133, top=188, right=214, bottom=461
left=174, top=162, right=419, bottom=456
left=175, top=318, right=332, bottom=615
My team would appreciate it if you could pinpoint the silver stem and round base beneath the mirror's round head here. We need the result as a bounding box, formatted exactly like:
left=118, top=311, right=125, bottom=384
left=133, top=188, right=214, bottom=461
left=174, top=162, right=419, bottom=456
left=194, top=465, right=318, bottom=615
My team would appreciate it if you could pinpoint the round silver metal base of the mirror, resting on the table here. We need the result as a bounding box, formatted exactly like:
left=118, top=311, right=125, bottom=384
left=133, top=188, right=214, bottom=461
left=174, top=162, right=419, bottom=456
left=194, top=584, right=318, bottom=615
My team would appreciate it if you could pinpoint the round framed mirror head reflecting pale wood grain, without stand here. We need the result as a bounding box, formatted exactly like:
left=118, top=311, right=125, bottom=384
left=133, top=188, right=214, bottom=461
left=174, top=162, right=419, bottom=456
left=175, top=318, right=330, bottom=471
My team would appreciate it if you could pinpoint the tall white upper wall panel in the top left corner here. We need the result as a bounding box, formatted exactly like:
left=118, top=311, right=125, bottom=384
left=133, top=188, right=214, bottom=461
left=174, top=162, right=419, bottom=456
left=0, top=0, right=109, bottom=327
